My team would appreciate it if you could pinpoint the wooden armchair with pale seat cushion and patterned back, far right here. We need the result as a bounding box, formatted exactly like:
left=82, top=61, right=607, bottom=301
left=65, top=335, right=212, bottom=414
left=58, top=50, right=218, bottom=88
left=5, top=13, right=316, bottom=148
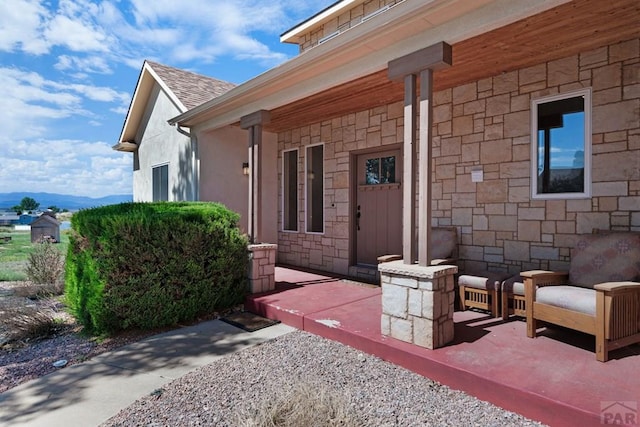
left=521, top=233, right=640, bottom=362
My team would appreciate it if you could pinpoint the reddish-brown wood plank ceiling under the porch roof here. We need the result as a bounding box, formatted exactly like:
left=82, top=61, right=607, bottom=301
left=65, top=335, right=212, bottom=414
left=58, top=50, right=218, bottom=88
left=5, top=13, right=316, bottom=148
left=266, top=0, right=640, bottom=132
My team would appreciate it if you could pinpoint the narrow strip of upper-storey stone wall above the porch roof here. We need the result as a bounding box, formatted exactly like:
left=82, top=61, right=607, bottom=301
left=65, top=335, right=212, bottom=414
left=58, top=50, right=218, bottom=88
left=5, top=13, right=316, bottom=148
left=298, top=0, right=404, bottom=53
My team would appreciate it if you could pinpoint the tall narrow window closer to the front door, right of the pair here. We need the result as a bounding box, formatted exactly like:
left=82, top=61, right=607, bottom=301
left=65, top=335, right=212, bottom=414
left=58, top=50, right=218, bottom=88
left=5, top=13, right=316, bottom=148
left=305, top=144, right=324, bottom=233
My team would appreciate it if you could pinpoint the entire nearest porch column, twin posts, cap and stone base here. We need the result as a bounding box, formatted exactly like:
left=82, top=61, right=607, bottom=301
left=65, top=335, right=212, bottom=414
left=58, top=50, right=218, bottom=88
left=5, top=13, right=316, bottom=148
left=378, top=42, right=458, bottom=349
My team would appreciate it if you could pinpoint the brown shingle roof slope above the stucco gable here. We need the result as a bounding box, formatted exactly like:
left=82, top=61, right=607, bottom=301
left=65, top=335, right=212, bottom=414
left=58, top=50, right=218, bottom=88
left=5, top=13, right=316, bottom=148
left=147, top=61, right=236, bottom=110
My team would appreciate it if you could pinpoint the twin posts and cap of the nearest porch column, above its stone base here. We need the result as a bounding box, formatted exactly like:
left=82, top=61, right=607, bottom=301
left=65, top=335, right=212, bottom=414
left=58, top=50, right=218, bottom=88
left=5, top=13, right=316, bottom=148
left=388, top=42, right=452, bottom=266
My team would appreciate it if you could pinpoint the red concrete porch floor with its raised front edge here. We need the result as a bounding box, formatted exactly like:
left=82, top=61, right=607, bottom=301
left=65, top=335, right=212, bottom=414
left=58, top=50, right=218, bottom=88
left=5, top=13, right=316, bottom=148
left=245, top=267, right=640, bottom=426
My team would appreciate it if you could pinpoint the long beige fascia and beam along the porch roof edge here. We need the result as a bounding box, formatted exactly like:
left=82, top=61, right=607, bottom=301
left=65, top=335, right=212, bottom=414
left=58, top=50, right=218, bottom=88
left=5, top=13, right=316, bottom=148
left=169, top=0, right=570, bottom=131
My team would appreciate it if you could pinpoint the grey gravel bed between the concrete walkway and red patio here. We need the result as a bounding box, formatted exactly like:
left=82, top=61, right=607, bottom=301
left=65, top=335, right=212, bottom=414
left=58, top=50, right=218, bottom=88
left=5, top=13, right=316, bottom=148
left=103, top=331, right=541, bottom=426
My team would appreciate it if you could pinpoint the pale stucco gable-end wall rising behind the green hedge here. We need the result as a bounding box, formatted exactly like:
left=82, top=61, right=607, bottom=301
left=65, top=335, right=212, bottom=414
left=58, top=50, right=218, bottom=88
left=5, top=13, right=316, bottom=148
left=133, top=84, right=195, bottom=202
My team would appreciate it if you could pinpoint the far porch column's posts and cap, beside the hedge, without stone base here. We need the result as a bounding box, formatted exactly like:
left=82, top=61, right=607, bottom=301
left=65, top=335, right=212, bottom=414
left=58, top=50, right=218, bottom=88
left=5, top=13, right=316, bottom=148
left=240, top=110, right=270, bottom=243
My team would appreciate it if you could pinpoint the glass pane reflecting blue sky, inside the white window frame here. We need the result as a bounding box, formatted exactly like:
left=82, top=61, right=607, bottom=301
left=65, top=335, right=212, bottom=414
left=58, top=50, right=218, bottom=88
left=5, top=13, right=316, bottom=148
left=537, top=96, right=585, bottom=194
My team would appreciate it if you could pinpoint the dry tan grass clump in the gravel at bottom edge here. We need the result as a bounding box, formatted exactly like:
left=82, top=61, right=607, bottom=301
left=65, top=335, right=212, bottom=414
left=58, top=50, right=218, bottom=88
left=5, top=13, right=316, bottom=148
left=238, top=382, right=363, bottom=427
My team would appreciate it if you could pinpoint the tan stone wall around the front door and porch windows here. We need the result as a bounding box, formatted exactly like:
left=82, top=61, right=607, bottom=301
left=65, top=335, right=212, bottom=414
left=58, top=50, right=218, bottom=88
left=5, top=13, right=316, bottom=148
left=278, top=39, right=640, bottom=274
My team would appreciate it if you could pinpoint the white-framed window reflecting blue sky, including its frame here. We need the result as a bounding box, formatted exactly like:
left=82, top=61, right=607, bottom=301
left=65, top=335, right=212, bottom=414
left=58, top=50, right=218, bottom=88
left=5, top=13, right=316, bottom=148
left=531, top=89, right=591, bottom=199
